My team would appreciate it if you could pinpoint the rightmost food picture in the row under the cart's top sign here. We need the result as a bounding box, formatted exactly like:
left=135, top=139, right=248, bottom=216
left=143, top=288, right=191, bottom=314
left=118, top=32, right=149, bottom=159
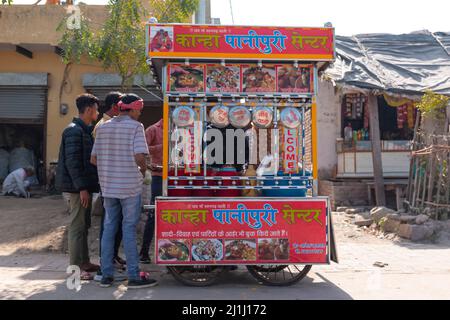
left=277, top=66, right=311, bottom=92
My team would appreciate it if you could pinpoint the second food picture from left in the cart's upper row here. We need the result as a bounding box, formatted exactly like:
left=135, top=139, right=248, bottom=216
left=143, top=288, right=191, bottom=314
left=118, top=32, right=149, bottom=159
left=206, top=66, right=240, bottom=92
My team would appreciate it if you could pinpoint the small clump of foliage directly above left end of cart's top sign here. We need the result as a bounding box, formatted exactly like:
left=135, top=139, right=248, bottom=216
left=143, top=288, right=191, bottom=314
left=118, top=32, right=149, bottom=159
left=150, top=0, right=199, bottom=23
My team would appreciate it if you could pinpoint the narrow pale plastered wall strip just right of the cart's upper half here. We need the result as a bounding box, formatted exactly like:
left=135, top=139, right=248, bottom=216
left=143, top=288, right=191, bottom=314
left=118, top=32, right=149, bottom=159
left=317, top=81, right=341, bottom=179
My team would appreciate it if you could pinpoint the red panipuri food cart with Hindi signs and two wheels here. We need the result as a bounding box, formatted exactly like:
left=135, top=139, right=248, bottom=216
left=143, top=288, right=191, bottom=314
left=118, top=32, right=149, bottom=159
left=146, top=23, right=337, bottom=286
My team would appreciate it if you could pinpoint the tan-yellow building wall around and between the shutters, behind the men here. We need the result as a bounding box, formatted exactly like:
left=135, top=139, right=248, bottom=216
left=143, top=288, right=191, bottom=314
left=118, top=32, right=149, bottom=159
left=0, top=51, right=105, bottom=166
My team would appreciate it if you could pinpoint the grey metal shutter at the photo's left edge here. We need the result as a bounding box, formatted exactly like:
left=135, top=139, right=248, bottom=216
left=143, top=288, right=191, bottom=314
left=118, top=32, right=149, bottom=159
left=0, top=86, right=47, bottom=124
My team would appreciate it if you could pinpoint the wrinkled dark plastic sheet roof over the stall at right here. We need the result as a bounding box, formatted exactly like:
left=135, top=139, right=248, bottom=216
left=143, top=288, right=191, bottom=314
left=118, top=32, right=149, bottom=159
left=325, top=30, right=450, bottom=96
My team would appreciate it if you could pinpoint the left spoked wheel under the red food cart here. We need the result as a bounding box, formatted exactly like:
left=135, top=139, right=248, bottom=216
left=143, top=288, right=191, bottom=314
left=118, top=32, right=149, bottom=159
left=167, top=266, right=225, bottom=287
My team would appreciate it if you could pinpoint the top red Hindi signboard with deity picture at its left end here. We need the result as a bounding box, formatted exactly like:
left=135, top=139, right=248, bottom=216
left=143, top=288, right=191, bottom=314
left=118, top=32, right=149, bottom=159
left=146, top=24, right=334, bottom=61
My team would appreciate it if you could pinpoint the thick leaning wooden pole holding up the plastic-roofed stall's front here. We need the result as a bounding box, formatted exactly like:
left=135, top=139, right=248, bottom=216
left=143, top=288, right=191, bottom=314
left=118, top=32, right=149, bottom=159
left=369, top=94, right=386, bottom=206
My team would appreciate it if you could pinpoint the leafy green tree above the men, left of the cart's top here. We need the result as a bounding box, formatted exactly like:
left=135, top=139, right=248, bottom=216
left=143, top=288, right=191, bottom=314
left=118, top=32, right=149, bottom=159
left=59, top=0, right=198, bottom=90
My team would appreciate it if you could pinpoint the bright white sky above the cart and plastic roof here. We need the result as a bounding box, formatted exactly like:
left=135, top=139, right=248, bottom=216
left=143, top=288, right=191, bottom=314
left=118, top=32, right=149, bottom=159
left=10, top=0, right=450, bottom=36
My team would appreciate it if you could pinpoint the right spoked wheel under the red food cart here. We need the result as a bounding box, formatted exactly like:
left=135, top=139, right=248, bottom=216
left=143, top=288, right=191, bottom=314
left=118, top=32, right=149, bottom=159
left=247, top=265, right=312, bottom=286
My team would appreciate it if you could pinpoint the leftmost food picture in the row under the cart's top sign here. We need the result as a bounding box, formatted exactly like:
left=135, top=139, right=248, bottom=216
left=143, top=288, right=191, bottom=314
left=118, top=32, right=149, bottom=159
left=170, top=65, right=203, bottom=92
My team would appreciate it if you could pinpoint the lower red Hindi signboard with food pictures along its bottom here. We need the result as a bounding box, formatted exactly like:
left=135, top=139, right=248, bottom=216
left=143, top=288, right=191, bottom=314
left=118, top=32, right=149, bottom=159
left=155, top=197, right=329, bottom=265
